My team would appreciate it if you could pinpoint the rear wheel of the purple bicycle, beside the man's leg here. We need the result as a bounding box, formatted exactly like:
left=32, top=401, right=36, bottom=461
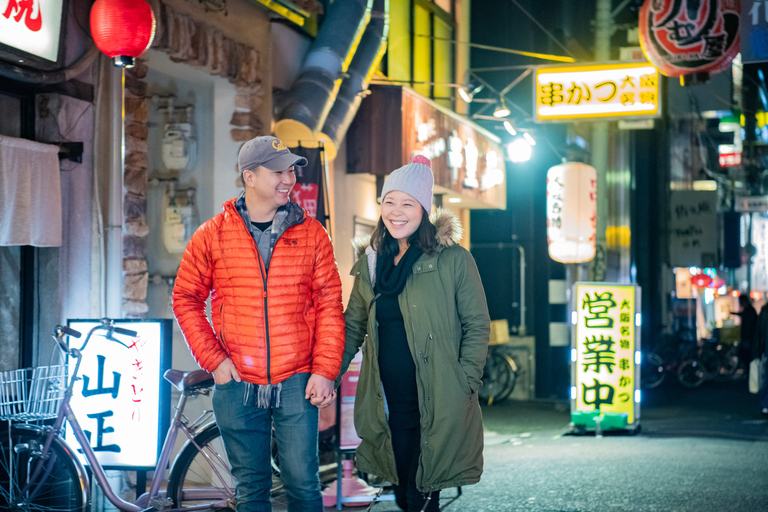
left=168, top=424, right=236, bottom=510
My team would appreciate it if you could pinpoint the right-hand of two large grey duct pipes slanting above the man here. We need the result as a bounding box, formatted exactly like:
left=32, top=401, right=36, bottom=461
left=321, top=0, right=389, bottom=152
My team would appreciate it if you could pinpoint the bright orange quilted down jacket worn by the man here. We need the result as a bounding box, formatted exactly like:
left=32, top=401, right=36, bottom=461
left=173, top=199, right=344, bottom=384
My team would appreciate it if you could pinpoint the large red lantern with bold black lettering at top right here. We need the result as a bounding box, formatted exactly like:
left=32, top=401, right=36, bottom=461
left=640, top=0, right=740, bottom=76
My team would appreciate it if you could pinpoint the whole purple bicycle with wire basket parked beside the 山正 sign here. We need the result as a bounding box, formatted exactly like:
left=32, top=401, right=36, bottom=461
left=0, top=318, right=236, bottom=512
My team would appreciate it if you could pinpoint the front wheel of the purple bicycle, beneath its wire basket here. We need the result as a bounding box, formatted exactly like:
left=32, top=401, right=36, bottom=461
left=0, top=425, right=88, bottom=512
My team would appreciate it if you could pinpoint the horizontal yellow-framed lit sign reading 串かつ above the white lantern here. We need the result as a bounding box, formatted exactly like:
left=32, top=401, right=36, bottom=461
left=534, top=62, right=660, bottom=121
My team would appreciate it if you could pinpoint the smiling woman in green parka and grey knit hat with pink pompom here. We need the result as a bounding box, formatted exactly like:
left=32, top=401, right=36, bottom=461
left=342, top=155, right=490, bottom=512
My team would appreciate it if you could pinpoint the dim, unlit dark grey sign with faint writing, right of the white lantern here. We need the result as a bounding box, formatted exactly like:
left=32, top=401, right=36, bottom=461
left=669, top=190, right=719, bottom=267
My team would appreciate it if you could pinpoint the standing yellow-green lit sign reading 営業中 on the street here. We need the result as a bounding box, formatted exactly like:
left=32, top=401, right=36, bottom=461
left=571, top=283, right=640, bottom=424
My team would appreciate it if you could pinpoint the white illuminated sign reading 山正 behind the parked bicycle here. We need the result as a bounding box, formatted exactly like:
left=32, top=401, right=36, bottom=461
left=66, top=320, right=172, bottom=469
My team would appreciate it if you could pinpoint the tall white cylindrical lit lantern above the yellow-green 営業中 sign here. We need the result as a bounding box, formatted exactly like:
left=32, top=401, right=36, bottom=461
left=547, top=162, right=597, bottom=263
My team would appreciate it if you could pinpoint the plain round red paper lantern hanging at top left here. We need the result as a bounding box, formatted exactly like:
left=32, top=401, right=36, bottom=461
left=91, top=0, right=155, bottom=68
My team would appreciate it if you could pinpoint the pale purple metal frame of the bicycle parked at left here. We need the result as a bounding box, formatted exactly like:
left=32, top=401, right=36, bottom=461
left=15, top=326, right=227, bottom=512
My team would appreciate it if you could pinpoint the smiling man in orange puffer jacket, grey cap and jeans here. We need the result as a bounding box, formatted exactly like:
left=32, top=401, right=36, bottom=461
left=173, top=137, right=344, bottom=512
